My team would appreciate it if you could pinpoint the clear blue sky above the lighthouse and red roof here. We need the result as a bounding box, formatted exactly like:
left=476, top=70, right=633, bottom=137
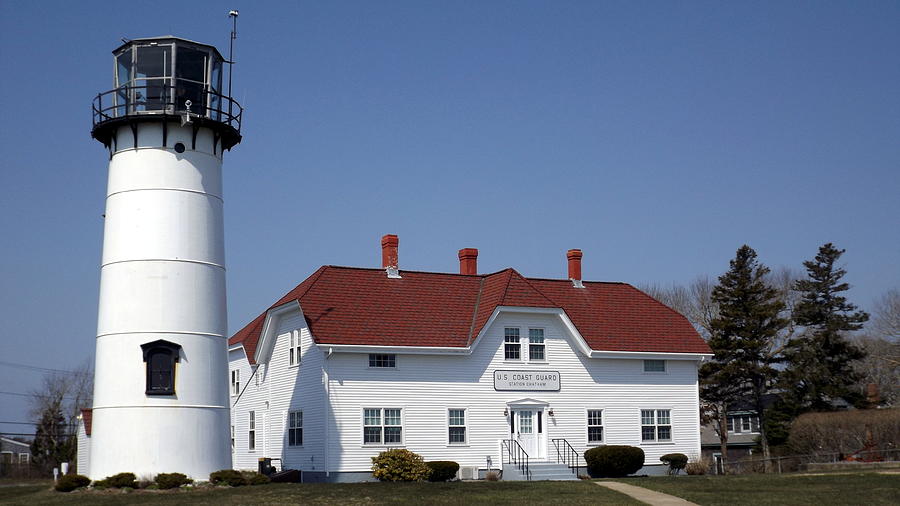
left=0, top=0, right=900, bottom=432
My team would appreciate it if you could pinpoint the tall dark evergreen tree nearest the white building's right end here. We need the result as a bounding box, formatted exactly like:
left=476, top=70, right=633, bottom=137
left=701, top=245, right=788, bottom=470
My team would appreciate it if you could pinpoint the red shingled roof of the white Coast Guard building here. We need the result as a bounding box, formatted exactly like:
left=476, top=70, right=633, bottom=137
left=228, top=266, right=710, bottom=363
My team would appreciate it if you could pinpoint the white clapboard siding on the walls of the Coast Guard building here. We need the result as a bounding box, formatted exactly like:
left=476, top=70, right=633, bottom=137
left=231, top=311, right=700, bottom=472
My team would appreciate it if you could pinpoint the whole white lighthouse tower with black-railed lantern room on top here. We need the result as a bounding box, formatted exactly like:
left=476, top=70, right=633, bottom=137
left=86, top=36, right=241, bottom=480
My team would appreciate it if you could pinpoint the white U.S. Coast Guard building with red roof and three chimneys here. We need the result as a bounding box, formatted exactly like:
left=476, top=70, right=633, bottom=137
left=229, top=235, right=711, bottom=481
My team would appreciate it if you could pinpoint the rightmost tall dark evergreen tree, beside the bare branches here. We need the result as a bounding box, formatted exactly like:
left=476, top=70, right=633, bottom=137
left=782, top=243, right=869, bottom=415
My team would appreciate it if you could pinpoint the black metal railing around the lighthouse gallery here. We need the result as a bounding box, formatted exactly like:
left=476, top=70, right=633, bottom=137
left=91, top=84, right=244, bottom=134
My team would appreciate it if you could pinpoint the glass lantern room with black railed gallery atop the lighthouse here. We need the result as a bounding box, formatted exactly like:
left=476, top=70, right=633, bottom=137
left=92, top=36, right=242, bottom=148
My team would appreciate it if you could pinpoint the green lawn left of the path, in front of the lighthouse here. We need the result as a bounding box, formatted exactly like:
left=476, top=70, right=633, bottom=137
left=0, top=481, right=643, bottom=506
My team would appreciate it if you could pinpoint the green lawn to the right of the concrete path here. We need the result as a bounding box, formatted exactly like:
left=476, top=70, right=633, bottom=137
left=619, top=473, right=900, bottom=506
